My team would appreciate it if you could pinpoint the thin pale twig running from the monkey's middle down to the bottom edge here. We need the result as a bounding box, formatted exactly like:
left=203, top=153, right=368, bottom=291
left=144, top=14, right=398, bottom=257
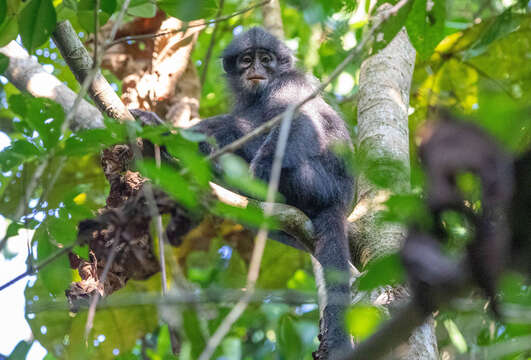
left=199, top=106, right=295, bottom=360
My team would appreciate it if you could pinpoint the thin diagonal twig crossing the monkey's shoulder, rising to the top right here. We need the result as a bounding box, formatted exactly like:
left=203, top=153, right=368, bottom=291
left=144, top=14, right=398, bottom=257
left=207, top=0, right=409, bottom=161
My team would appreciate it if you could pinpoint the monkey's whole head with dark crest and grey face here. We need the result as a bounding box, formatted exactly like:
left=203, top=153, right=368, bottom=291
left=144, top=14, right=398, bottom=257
left=222, top=27, right=294, bottom=96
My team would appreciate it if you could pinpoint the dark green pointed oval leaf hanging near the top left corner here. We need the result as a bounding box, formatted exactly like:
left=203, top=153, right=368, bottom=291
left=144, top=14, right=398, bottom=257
left=18, top=0, right=57, bottom=53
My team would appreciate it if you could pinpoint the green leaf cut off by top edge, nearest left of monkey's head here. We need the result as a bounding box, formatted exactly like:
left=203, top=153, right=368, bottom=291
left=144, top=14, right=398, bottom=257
left=157, top=0, right=217, bottom=21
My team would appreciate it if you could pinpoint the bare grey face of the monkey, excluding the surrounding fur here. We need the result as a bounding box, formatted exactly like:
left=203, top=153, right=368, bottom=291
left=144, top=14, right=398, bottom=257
left=236, top=49, right=278, bottom=94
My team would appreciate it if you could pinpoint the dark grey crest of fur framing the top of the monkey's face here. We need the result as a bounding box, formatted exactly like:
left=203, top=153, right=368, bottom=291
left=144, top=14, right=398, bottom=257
left=222, top=27, right=294, bottom=73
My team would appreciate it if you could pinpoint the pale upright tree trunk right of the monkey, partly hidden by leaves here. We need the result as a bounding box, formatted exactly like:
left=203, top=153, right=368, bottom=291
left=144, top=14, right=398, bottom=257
left=349, top=30, right=438, bottom=360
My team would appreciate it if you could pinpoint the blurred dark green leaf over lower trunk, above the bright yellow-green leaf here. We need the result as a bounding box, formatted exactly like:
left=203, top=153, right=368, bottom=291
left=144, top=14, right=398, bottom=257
left=358, top=254, right=405, bottom=291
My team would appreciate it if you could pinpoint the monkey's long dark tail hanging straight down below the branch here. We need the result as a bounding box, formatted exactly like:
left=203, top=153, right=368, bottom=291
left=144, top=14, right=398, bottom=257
left=312, top=207, right=352, bottom=359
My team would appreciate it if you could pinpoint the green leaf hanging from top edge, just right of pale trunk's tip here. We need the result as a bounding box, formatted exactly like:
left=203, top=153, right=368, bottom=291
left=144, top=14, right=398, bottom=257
left=406, top=0, right=446, bottom=60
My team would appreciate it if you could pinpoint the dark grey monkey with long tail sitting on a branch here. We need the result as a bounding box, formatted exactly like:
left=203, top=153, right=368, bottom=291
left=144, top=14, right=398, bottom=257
left=134, top=27, right=354, bottom=359
